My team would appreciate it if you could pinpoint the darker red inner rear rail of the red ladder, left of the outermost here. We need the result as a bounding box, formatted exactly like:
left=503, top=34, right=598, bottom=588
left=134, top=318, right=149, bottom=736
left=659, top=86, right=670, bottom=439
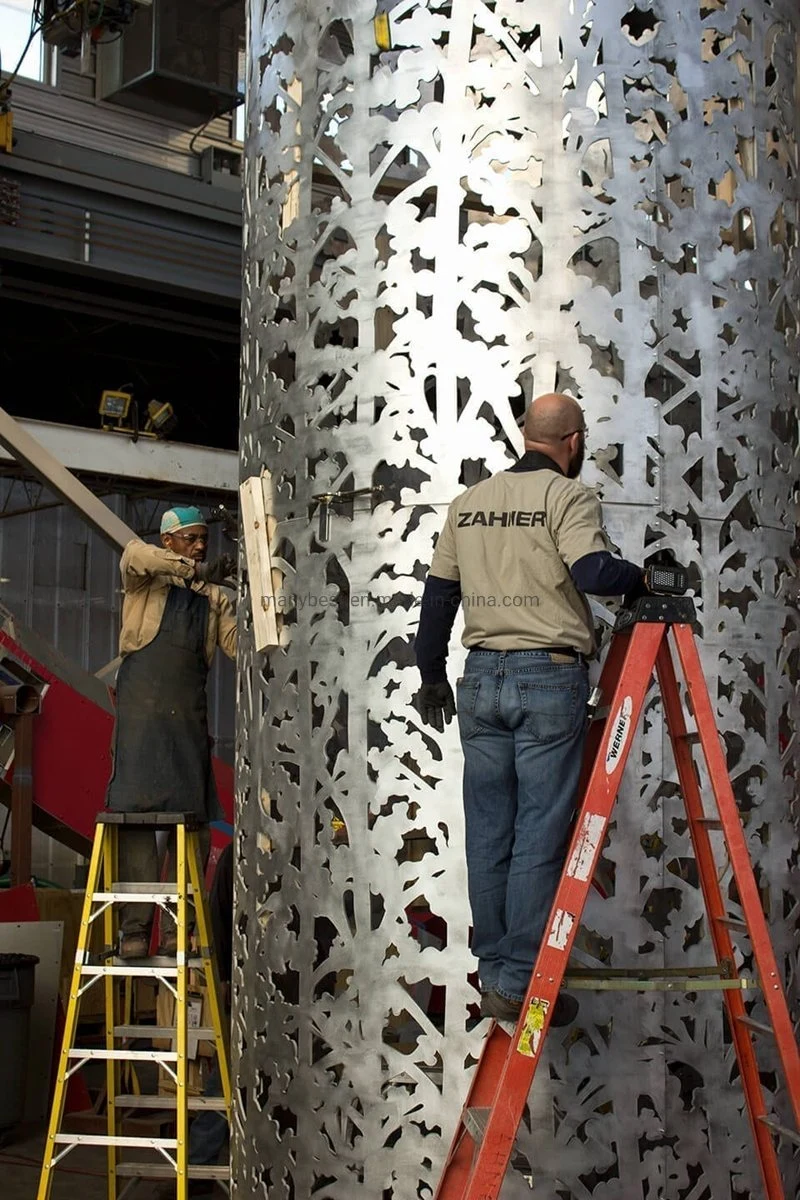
left=656, top=626, right=784, bottom=1200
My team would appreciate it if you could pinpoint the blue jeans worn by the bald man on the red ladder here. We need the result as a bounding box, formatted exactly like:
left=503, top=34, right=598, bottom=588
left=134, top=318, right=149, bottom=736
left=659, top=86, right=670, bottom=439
left=457, top=650, right=589, bottom=1000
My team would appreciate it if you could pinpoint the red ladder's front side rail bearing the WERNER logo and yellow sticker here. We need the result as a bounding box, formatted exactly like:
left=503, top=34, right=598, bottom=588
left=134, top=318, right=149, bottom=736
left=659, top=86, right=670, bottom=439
left=464, top=623, right=666, bottom=1200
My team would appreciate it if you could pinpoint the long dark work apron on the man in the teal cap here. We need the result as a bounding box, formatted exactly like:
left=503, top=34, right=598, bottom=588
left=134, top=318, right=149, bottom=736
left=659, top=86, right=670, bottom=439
left=106, top=587, right=223, bottom=821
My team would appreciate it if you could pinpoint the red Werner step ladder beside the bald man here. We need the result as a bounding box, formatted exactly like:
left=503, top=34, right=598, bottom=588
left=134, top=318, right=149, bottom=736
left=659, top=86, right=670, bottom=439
left=435, top=596, right=800, bottom=1200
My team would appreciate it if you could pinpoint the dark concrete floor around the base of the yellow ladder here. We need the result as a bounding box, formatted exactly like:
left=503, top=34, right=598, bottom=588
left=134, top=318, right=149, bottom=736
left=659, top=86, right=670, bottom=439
left=0, top=1127, right=227, bottom=1200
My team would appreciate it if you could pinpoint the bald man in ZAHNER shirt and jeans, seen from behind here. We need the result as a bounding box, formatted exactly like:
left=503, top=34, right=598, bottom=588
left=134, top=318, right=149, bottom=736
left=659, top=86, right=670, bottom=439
left=416, top=394, right=645, bottom=1025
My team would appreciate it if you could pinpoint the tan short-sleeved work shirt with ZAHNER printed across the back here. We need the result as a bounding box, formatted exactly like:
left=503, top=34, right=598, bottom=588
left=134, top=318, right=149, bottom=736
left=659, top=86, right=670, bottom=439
left=431, top=467, right=609, bottom=654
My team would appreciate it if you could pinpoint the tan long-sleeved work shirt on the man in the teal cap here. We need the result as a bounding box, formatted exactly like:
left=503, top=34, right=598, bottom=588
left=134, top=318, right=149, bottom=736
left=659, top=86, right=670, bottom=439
left=120, top=540, right=236, bottom=666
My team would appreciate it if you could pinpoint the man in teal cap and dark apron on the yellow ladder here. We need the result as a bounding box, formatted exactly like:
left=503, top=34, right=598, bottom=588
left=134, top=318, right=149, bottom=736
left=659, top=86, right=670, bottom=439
left=107, top=506, right=236, bottom=959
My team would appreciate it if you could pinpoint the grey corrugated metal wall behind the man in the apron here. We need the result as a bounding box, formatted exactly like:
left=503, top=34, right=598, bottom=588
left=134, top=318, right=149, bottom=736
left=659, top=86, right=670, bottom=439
left=0, top=476, right=235, bottom=887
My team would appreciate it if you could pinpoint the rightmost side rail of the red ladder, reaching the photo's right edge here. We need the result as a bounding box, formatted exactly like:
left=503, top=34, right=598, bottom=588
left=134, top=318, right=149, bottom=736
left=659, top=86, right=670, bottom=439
left=674, top=625, right=800, bottom=1132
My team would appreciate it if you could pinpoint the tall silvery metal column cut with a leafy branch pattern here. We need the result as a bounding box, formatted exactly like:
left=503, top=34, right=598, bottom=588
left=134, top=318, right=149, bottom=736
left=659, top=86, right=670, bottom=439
left=234, top=0, right=800, bottom=1200
